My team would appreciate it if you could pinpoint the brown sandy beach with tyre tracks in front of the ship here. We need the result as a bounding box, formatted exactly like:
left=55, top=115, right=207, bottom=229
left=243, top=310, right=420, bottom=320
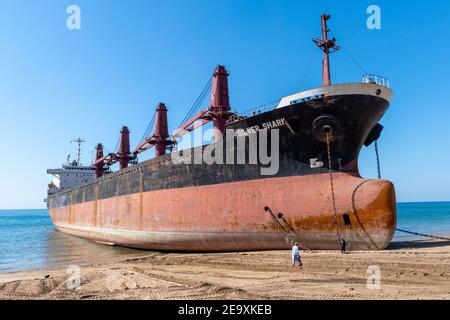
left=0, top=241, right=450, bottom=300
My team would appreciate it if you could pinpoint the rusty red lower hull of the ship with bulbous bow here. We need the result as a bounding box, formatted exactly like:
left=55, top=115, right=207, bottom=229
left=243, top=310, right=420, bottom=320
left=50, top=174, right=396, bottom=251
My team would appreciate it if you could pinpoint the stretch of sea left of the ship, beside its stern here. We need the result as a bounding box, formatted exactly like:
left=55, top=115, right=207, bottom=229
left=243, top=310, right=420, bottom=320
left=0, top=210, right=147, bottom=272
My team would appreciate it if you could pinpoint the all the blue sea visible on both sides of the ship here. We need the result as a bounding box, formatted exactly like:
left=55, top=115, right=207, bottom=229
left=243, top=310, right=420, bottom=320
left=0, top=201, right=450, bottom=273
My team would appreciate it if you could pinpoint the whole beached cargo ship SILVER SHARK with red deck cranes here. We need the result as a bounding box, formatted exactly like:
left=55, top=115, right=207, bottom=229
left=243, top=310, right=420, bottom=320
left=46, top=14, right=396, bottom=252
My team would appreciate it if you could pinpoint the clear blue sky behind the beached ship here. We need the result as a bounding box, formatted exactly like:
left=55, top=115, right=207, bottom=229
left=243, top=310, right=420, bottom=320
left=0, top=0, right=450, bottom=208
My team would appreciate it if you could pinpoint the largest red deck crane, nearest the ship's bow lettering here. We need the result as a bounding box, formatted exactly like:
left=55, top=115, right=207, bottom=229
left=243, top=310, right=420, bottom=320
left=173, top=65, right=233, bottom=141
